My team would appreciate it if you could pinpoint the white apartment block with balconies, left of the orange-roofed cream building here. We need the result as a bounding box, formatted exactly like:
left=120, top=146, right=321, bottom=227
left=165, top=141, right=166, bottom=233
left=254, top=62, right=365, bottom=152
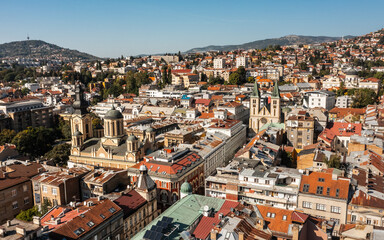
left=205, top=158, right=301, bottom=210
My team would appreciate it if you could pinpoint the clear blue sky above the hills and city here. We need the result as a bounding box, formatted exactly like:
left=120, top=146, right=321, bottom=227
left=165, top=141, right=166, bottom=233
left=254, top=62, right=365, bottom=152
left=0, top=0, right=384, bottom=57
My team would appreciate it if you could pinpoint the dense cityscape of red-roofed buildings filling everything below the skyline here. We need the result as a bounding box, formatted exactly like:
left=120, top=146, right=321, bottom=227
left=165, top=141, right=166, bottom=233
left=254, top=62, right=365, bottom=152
left=0, top=15, right=384, bottom=240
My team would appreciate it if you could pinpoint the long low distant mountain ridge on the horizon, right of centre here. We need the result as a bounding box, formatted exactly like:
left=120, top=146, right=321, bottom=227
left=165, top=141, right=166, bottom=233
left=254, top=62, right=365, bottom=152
left=186, top=35, right=354, bottom=53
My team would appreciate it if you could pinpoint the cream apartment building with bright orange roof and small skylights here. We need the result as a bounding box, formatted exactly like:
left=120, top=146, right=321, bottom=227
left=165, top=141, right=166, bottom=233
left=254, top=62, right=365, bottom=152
left=297, top=169, right=351, bottom=224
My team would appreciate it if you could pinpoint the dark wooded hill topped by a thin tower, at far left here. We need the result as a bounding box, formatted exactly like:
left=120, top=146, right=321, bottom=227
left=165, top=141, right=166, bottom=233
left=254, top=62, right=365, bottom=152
left=0, top=40, right=100, bottom=60
